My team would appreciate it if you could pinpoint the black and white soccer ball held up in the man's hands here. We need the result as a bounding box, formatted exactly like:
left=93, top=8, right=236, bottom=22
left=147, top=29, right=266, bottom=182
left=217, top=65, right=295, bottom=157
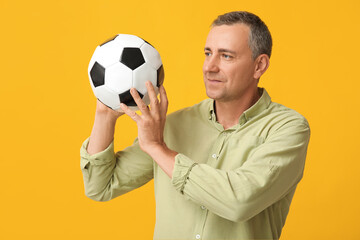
left=88, top=34, right=164, bottom=111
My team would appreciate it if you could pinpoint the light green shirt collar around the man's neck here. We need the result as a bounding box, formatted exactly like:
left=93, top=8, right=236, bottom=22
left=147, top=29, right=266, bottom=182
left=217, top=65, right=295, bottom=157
left=209, top=88, right=271, bottom=125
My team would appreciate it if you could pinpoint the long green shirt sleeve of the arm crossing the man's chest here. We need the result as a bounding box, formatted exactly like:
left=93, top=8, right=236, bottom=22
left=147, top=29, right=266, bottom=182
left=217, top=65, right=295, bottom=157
left=171, top=120, right=310, bottom=222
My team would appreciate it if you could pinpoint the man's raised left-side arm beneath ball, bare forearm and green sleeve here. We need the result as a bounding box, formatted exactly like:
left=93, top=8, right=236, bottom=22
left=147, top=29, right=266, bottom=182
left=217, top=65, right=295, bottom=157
left=80, top=101, right=153, bottom=201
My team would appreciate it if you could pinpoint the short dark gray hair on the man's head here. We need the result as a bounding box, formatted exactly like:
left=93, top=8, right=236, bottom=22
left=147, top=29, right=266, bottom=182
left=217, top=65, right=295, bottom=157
left=211, top=11, right=272, bottom=60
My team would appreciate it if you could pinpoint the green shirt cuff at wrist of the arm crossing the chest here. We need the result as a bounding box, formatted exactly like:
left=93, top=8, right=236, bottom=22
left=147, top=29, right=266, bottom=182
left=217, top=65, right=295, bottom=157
left=171, top=153, right=198, bottom=194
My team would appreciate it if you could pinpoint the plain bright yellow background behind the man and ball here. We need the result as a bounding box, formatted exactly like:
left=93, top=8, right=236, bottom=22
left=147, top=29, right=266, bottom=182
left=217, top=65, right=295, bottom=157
left=0, top=0, right=360, bottom=240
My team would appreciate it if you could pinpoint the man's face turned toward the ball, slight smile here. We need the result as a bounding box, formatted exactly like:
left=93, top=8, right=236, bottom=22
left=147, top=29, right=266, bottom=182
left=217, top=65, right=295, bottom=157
left=203, top=24, right=258, bottom=102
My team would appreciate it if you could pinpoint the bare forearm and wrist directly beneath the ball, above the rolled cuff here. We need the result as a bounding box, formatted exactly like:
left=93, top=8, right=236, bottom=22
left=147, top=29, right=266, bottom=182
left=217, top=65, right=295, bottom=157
left=87, top=100, right=124, bottom=155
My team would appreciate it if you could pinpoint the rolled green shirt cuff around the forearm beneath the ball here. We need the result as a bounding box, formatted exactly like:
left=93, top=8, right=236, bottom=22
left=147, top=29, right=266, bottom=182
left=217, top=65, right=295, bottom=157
left=80, top=137, right=115, bottom=169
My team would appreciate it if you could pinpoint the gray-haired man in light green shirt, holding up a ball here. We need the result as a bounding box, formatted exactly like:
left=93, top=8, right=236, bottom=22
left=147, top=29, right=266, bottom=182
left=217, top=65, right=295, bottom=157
left=81, top=12, right=310, bottom=239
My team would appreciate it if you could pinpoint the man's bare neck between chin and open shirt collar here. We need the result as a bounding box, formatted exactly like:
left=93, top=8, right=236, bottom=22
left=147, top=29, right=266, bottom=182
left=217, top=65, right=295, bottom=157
left=215, top=89, right=260, bottom=129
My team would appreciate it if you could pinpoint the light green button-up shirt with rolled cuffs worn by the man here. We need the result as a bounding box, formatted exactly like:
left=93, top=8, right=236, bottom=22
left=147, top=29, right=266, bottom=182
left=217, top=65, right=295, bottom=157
left=80, top=89, right=310, bottom=240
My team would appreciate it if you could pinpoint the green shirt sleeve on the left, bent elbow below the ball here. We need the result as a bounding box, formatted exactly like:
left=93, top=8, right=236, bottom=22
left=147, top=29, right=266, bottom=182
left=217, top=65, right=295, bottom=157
left=80, top=138, right=153, bottom=201
